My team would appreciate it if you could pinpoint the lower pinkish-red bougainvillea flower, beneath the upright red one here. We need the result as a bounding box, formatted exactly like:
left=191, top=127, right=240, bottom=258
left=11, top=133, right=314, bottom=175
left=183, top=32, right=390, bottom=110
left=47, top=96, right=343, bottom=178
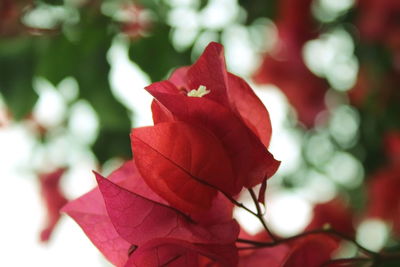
left=63, top=161, right=239, bottom=266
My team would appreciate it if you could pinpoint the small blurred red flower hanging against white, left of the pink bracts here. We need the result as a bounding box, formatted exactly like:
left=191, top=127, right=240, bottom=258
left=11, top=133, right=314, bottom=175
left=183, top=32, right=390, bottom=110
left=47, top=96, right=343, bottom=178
left=39, top=168, right=68, bottom=242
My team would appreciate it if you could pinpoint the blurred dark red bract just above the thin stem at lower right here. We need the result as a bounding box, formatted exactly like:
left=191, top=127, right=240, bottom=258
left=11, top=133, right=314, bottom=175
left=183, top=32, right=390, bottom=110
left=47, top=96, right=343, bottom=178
left=305, top=198, right=355, bottom=237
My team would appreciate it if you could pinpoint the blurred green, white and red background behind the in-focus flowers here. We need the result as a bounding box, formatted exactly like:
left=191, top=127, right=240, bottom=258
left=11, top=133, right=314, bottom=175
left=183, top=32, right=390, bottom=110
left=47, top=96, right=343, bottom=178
left=0, top=0, right=400, bottom=266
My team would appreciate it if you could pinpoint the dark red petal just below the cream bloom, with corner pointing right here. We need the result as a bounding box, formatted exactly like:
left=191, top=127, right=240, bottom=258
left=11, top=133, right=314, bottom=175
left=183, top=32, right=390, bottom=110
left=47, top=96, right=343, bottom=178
left=146, top=87, right=280, bottom=192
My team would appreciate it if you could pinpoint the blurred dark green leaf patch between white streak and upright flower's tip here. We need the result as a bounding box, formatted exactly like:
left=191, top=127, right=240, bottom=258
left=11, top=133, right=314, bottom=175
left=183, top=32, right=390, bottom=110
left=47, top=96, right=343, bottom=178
left=129, top=24, right=191, bottom=81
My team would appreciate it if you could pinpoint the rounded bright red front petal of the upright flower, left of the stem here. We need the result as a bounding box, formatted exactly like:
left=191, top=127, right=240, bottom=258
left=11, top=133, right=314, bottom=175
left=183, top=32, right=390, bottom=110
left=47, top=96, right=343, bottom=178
left=131, top=123, right=234, bottom=213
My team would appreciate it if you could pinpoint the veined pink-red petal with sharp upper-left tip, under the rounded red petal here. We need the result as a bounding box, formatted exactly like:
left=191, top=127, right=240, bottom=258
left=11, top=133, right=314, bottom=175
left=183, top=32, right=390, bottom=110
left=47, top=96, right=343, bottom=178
left=96, top=174, right=236, bottom=246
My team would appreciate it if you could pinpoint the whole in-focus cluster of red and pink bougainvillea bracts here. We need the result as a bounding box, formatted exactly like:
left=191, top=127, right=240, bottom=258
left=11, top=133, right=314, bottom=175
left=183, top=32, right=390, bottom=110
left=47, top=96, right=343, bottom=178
left=63, top=43, right=348, bottom=266
